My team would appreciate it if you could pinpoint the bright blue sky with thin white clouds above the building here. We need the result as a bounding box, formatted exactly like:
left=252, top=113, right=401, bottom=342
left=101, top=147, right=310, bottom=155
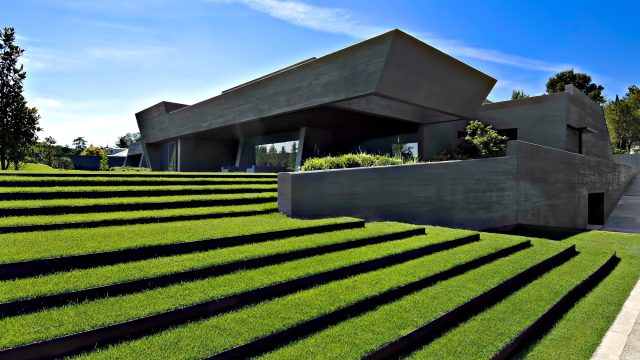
left=0, top=0, right=640, bottom=145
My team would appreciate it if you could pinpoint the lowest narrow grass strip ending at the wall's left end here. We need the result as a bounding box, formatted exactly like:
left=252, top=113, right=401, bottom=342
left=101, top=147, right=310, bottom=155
left=0, top=201, right=278, bottom=227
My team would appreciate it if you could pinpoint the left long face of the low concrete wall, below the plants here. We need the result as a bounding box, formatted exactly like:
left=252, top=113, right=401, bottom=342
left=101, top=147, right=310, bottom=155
left=278, top=157, right=516, bottom=228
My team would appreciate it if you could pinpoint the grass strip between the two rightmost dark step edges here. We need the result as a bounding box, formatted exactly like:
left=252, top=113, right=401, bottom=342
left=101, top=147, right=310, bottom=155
left=411, top=254, right=608, bottom=359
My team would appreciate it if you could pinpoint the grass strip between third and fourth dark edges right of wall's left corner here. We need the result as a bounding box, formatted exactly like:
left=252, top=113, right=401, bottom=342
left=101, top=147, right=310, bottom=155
left=77, top=235, right=515, bottom=358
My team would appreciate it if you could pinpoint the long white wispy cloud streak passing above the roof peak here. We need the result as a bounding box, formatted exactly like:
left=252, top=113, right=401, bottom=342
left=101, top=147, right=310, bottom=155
left=208, top=0, right=576, bottom=72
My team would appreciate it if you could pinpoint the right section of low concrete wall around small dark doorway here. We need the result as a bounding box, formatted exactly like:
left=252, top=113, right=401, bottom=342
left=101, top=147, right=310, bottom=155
left=507, top=141, right=635, bottom=228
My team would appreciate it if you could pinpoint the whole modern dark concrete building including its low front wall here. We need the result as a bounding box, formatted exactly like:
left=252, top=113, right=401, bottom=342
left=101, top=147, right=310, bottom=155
left=136, top=30, right=636, bottom=228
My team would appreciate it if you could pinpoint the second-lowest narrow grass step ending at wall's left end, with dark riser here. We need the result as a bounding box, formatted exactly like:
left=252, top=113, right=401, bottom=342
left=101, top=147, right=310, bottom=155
left=0, top=192, right=277, bottom=216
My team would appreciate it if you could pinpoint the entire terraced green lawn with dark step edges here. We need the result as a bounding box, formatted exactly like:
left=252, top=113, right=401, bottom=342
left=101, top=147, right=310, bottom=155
left=0, top=171, right=640, bottom=359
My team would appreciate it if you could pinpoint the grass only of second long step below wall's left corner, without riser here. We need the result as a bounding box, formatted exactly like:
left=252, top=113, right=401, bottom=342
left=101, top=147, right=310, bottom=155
left=0, top=222, right=416, bottom=303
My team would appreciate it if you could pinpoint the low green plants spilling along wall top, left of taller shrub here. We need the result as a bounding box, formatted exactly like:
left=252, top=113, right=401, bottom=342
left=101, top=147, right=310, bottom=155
left=300, top=153, right=404, bottom=171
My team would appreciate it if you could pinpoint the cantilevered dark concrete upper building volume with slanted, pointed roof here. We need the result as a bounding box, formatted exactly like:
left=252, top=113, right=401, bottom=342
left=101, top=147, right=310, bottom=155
left=136, top=30, right=496, bottom=171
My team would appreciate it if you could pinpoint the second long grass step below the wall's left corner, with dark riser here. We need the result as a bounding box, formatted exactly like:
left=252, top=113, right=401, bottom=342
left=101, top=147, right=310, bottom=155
left=0, top=223, right=424, bottom=317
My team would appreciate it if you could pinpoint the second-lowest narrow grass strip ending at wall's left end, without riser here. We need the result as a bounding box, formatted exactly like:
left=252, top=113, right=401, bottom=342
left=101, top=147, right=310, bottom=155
left=0, top=192, right=278, bottom=209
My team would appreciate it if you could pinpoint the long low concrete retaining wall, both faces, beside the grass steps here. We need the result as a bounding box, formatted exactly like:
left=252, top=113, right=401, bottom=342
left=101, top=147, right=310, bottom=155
left=278, top=141, right=635, bottom=229
